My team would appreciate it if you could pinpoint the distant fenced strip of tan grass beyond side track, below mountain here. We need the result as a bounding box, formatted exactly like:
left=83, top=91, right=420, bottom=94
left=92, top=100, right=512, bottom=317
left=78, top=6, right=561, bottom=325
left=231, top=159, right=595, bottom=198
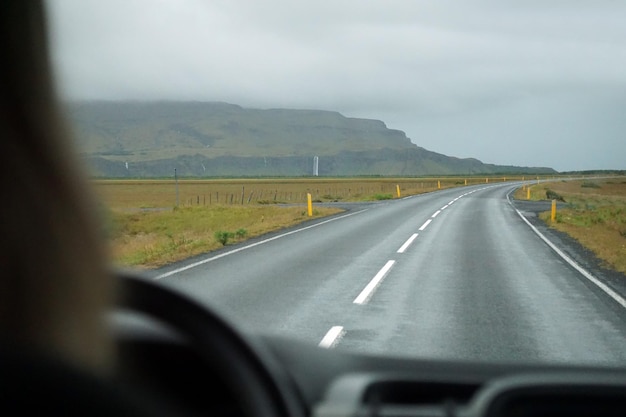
left=93, top=177, right=521, bottom=210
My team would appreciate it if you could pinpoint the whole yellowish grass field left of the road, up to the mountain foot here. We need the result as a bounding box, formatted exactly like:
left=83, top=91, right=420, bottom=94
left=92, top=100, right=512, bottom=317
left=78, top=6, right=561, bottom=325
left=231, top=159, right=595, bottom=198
left=93, top=177, right=536, bottom=268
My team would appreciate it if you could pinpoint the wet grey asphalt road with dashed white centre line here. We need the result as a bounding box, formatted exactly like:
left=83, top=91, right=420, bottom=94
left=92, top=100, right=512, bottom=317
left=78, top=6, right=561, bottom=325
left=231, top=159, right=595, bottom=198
left=155, top=184, right=626, bottom=365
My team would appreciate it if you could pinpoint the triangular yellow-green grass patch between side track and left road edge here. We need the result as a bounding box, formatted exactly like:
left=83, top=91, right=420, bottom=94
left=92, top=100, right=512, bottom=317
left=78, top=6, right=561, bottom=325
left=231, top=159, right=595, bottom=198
left=107, top=205, right=341, bottom=268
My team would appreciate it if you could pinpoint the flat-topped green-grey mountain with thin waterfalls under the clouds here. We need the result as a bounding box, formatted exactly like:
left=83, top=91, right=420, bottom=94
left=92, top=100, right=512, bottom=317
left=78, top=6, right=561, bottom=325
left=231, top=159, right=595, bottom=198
left=66, top=101, right=555, bottom=177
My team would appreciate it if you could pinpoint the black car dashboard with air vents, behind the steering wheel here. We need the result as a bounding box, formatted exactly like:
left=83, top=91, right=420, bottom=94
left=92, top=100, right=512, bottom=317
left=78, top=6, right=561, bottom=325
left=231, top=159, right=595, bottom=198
left=112, top=272, right=626, bottom=417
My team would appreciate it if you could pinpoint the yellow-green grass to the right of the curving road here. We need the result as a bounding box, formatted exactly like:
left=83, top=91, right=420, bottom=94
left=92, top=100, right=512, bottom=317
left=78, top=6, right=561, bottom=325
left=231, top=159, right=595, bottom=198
left=515, top=177, right=626, bottom=273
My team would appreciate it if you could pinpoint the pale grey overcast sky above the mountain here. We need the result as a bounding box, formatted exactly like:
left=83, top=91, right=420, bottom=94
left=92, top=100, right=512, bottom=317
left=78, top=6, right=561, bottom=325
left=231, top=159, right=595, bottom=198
left=47, top=0, right=626, bottom=171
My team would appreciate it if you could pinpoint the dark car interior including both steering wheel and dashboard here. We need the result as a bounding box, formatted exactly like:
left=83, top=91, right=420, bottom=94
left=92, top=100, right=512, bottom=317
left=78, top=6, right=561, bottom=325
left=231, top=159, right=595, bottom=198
left=0, top=0, right=626, bottom=417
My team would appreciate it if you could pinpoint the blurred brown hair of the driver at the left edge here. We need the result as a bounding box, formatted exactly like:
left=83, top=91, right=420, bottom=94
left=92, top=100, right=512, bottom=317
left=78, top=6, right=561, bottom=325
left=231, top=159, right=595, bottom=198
left=0, top=0, right=112, bottom=369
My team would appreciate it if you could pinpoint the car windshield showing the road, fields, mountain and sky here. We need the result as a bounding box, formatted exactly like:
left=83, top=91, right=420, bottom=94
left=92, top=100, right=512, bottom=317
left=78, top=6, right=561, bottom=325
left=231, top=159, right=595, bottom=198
left=47, top=0, right=626, bottom=366
